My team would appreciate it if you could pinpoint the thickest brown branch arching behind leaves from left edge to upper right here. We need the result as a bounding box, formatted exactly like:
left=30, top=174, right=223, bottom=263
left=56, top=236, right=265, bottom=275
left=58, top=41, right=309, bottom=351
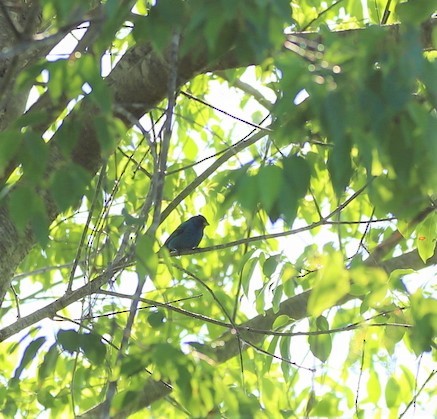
left=0, top=13, right=437, bottom=299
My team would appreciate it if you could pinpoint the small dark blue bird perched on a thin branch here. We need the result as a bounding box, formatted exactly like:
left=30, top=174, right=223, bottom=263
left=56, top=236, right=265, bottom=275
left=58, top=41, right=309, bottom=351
left=164, top=215, right=209, bottom=251
